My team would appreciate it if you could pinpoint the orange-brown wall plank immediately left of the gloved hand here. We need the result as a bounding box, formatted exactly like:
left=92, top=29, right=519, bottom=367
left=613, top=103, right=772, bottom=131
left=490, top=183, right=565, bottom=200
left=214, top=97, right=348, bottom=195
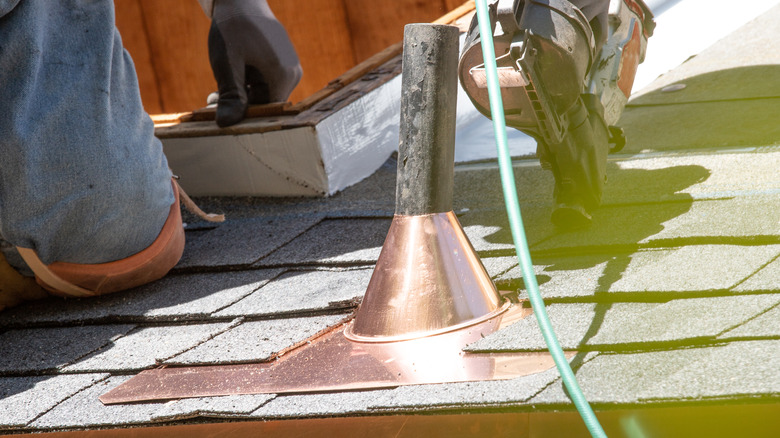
left=139, top=0, right=212, bottom=112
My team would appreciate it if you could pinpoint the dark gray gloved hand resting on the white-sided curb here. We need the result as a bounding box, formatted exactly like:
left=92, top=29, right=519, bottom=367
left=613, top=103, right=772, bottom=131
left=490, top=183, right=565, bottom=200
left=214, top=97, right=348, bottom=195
left=208, top=0, right=303, bottom=127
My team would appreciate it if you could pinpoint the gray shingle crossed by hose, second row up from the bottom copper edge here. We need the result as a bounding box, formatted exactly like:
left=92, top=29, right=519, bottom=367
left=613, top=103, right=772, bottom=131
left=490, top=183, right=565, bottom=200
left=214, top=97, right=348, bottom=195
left=467, top=294, right=780, bottom=351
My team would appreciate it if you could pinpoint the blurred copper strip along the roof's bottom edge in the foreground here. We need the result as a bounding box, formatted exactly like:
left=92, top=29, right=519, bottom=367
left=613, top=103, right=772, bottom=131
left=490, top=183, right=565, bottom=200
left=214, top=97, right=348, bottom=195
left=7, top=400, right=780, bottom=438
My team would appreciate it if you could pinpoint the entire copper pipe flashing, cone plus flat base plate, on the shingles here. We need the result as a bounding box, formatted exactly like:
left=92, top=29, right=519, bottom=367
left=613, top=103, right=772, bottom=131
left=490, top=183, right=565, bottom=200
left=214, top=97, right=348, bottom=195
left=100, top=211, right=555, bottom=404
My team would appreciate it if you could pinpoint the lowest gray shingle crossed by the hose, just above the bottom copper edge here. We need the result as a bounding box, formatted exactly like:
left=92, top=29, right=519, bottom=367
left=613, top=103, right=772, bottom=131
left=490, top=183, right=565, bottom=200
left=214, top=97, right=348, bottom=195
left=529, top=340, right=780, bottom=404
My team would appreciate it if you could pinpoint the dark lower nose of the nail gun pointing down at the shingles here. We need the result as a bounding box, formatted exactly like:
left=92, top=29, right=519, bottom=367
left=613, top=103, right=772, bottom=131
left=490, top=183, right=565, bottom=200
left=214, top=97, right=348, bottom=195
left=537, top=94, right=609, bottom=230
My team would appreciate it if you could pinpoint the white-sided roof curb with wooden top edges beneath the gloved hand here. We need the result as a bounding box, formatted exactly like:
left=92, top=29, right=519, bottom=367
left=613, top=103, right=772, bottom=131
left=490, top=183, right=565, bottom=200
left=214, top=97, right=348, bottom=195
left=138, top=0, right=473, bottom=196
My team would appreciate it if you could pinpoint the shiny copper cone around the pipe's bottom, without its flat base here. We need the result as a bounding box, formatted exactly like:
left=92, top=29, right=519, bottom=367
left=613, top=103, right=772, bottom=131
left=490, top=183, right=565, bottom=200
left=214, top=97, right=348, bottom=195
left=345, top=212, right=503, bottom=342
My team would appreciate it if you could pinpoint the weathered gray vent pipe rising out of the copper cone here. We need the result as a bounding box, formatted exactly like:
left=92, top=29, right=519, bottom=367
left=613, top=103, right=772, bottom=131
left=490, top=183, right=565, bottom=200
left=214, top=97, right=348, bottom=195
left=395, top=24, right=458, bottom=216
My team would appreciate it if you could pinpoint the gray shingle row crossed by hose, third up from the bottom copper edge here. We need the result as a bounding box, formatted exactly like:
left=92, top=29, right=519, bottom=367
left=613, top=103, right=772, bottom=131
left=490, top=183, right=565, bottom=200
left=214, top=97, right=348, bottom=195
left=496, top=245, right=780, bottom=301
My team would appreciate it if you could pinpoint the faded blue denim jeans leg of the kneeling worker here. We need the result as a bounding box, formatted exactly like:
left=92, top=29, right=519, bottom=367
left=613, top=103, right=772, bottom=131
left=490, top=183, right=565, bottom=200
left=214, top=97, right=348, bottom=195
left=0, top=0, right=174, bottom=268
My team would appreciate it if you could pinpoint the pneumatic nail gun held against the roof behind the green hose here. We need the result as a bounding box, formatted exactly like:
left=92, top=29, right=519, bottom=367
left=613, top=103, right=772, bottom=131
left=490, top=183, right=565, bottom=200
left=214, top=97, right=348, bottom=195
left=458, top=0, right=655, bottom=228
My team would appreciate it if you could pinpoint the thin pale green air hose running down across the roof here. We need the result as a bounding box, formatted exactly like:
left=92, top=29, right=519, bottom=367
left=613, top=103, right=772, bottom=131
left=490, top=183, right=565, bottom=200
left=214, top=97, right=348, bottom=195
left=476, top=0, right=607, bottom=437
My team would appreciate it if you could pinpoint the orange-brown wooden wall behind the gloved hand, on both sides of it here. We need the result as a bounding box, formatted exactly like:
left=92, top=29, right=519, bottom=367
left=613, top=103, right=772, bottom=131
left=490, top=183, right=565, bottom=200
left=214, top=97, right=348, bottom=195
left=114, top=0, right=465, bottom=114
